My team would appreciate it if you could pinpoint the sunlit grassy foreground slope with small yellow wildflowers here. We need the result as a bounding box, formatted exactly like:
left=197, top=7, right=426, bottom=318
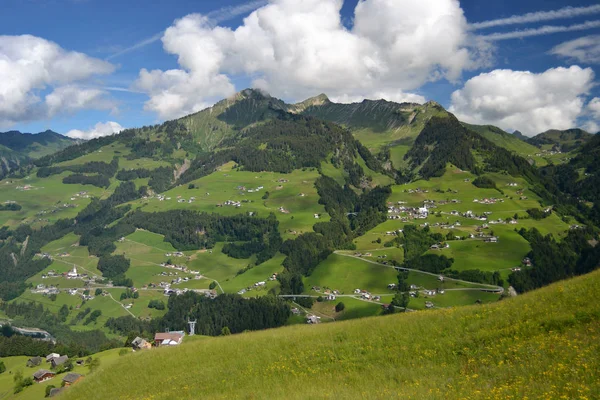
left=64, top=272, right=600, bottom=399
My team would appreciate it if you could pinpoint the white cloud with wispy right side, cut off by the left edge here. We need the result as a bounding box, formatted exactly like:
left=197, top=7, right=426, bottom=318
left=0, top=35, right=114, bottom=125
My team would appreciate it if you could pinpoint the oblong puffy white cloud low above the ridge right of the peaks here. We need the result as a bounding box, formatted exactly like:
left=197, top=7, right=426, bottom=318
left=450, top=66, right=594, bottom=136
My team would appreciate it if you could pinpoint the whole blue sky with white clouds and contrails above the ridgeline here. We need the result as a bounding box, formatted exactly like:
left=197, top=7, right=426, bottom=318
left=0, top=0, right=600, bottom=139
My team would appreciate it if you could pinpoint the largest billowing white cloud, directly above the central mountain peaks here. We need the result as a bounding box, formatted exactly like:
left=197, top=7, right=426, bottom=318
left=135, top=0, right=491, bottom=118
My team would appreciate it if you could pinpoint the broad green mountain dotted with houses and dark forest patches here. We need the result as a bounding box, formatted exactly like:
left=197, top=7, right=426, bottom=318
left=0, top=90, right=600, bottom=390
